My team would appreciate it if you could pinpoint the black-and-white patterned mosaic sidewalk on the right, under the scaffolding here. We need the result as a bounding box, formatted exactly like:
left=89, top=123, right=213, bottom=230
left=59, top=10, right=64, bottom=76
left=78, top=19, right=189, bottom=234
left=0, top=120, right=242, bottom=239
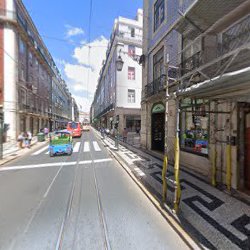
left=95, top=130, right=250, bottom=249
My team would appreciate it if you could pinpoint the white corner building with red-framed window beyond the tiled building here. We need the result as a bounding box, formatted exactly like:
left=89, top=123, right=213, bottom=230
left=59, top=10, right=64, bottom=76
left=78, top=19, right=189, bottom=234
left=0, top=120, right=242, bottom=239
left=91, top=10, right=143, bottom=133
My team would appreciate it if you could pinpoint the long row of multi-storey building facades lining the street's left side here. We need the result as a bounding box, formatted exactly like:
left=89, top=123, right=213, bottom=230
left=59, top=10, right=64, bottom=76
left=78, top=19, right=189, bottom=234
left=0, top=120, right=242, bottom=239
left=0, top=0, right=71, bottom=140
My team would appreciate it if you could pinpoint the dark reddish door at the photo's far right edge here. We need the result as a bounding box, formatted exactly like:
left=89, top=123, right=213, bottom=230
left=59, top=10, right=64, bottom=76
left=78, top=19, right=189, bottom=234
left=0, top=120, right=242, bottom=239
left=244, top=113, right=250, bottom=190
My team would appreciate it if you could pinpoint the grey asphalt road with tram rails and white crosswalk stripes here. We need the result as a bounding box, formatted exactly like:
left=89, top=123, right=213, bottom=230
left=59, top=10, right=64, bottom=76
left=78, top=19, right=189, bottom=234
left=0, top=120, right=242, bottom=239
left=0, top=131, right=188, bottom=250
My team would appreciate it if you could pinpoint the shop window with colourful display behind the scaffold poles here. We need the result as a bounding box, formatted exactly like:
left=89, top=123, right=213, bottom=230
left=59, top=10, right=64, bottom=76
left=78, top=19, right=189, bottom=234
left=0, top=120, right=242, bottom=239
left=180, top=99, right=209, bottom=155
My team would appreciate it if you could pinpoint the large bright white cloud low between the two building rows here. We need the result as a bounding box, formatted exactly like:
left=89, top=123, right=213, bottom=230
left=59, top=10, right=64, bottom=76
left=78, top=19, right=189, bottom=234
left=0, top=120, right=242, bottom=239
left=63, top=36, right=108, bottom=111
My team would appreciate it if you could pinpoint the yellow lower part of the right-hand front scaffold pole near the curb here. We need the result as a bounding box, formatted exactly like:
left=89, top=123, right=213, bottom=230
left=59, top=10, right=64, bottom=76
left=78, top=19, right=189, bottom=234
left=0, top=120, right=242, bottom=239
left=174, top=137, right=181, bottom=213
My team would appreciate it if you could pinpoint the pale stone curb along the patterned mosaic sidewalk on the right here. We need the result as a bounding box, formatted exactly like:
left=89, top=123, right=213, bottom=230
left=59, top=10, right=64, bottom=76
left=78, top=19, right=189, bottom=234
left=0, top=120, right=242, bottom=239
left=103, top=142, right=203, bottom=249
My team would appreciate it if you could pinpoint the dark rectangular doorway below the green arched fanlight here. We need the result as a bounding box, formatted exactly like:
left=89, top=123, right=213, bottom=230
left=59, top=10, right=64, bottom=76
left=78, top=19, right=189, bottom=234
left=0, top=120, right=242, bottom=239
left=151, top=113, right=165, bottom=152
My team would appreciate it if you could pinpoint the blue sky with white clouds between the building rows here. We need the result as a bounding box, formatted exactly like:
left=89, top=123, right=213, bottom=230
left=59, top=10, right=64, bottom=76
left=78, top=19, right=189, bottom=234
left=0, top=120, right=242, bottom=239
left=23, top=0, right=143, bottom=112
